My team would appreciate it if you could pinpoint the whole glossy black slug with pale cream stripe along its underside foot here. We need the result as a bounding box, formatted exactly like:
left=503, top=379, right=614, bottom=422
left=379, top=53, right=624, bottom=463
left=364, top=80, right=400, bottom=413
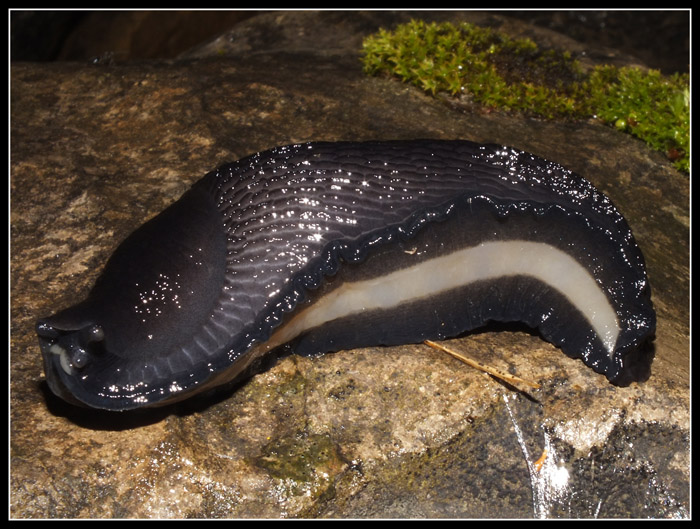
left=37, top=140, right=656, bottom=410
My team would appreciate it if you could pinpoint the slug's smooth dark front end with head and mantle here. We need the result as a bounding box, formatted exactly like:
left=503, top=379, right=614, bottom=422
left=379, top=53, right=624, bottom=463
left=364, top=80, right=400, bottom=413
left=36, top=185, right=226, bottom=410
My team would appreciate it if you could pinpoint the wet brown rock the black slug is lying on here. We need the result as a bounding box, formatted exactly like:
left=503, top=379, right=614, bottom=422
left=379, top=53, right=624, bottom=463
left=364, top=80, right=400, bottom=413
left=10, top=12, right=690, bottom=518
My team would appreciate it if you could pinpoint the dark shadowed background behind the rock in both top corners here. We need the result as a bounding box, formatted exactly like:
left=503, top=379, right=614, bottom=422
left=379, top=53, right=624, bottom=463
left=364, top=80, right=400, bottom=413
left=10, top=10, right=690, bottom=74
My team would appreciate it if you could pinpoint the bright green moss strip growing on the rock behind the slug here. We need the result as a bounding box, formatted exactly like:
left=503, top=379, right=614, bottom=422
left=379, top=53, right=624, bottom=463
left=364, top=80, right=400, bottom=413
left=363, top=20, right=690, bottom=172
